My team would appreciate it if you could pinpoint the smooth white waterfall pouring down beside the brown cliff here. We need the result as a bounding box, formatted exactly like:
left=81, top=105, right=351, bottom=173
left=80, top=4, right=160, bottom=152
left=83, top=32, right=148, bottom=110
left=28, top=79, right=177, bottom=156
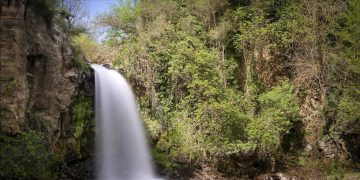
left=92, top=65, right=156, bottom=180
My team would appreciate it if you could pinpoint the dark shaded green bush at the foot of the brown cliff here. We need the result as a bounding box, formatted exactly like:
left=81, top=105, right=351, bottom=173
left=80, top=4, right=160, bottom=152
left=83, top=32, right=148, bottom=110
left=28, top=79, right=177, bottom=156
left=0, top=131, right=54, bottom=179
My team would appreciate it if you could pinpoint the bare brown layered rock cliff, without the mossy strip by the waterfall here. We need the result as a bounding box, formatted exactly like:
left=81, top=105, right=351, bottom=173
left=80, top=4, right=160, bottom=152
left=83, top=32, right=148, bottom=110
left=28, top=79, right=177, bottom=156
left=0, top=1, right=77, bottom=135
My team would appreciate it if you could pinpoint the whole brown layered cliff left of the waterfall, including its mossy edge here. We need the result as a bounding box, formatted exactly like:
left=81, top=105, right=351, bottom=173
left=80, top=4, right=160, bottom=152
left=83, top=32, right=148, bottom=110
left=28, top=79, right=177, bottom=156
left=0, top=0, right=93, bottom=166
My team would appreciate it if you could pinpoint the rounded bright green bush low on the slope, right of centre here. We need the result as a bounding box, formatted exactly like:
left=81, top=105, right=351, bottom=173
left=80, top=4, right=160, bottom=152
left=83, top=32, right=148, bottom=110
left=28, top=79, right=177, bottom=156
left=247, top=81, right=300, bottom=153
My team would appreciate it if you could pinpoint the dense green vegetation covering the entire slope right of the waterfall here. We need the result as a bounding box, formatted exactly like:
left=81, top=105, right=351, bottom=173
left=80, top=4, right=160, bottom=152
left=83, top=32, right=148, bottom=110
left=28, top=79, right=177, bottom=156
left=71, top=0, right=360, bottom=173
